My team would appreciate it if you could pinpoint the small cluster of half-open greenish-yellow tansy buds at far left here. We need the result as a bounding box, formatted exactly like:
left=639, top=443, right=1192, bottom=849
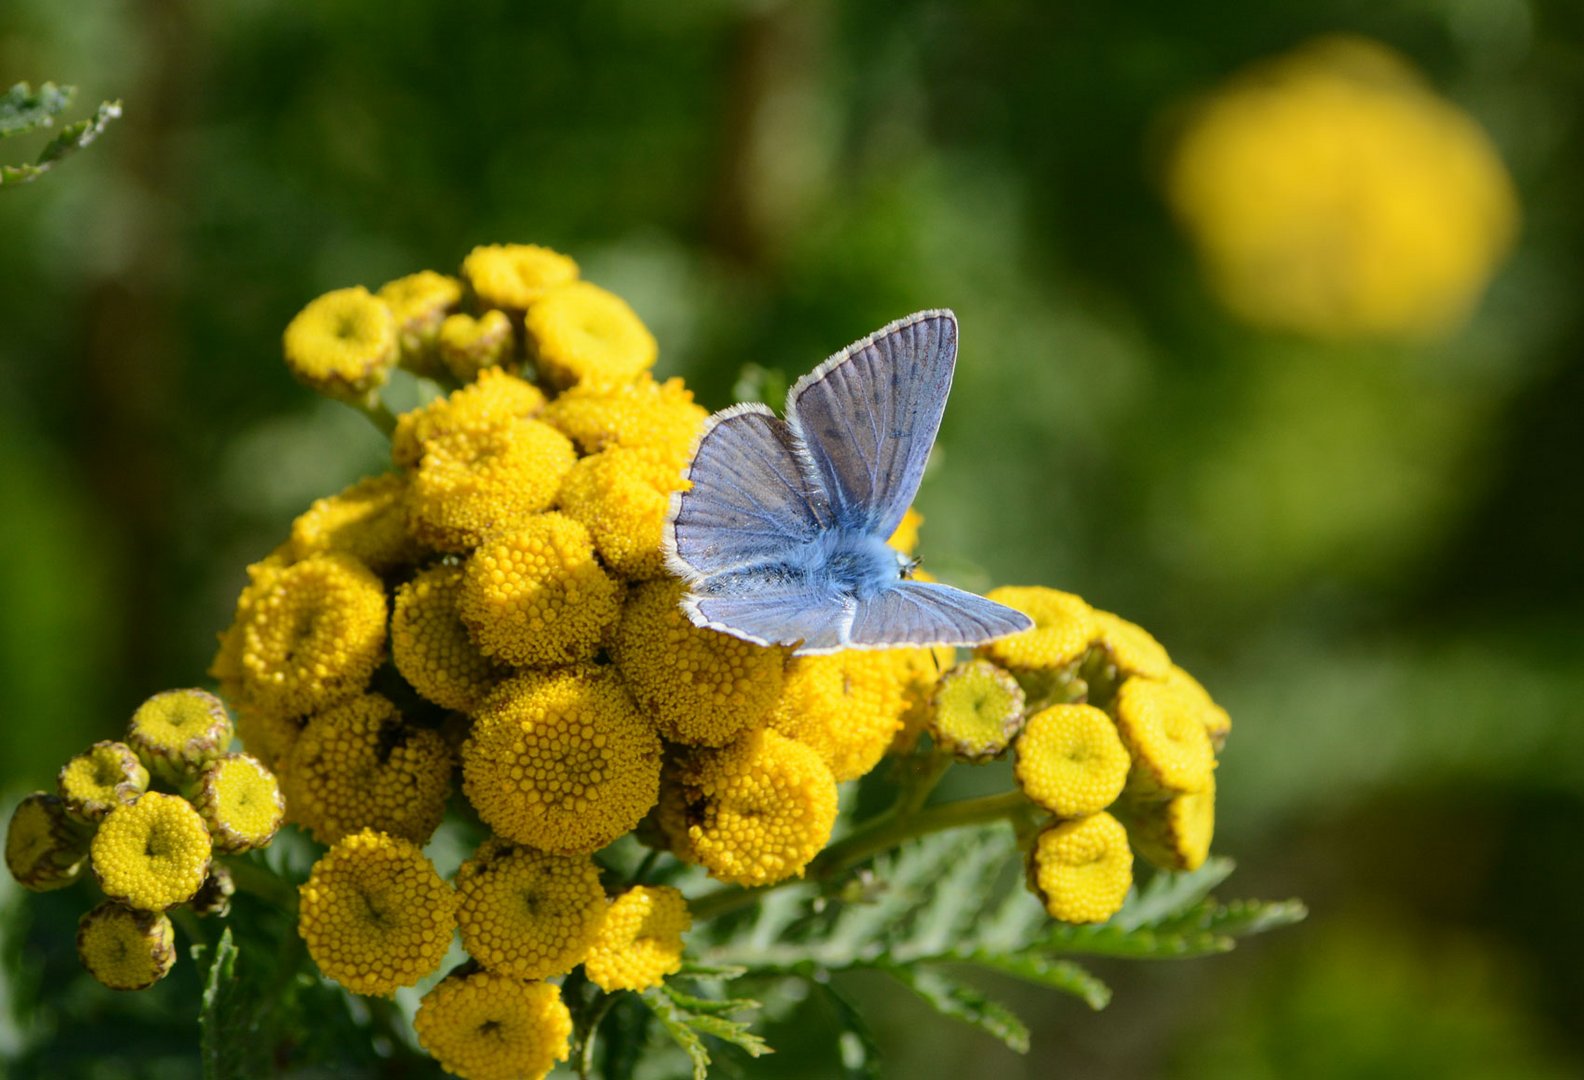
left=6, top=690, right=285, bottom=990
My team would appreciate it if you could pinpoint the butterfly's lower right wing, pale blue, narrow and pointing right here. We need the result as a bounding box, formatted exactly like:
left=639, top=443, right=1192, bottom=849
left=849, top=581, right=1034, bottom=648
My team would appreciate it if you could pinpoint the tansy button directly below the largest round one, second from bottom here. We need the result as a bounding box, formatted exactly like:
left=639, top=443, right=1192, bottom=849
left=456, top=841, right=607, bottom=979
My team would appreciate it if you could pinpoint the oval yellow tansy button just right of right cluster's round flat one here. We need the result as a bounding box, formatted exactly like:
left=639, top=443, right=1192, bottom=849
left=1110, top=678, right=1215, bottom=798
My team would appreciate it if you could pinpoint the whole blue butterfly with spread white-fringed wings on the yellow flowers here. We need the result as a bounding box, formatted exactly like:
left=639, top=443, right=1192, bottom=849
left=664, top=310, right=1033, bottom=654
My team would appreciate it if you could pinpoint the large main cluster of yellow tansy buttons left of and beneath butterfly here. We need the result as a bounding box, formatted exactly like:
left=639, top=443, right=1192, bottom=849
left=212, top=244, right=949, bottom=1077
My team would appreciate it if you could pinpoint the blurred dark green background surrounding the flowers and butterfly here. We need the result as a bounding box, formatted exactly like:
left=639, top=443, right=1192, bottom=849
left=0, top=0, right=1584, bottom=1080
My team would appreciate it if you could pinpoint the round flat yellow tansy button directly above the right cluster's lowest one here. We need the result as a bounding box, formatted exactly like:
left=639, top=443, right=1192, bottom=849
left=1012, top=705, right=1131, bottom=817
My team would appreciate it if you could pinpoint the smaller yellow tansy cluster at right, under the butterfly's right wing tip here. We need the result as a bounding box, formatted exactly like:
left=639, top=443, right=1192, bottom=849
left=928, top=586, right=1231, bottom=923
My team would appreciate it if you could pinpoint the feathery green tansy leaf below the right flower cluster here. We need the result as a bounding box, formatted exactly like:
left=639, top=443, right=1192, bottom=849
left=706, top=827, right=1305, bottom=1051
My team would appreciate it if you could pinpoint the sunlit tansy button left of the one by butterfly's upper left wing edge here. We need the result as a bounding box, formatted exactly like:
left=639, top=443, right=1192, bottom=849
left=407, top=420, right=578, bottom=551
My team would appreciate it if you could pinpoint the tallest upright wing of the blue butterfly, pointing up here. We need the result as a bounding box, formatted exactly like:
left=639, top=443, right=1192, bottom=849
left=787, top=310, right=957, bottom=537
